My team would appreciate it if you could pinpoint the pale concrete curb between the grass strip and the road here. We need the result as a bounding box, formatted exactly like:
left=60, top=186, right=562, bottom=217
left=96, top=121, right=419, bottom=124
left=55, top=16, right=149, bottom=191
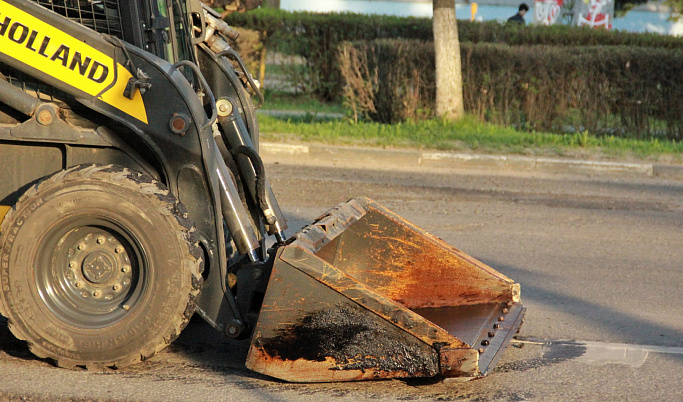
left=260, top=142, right=683, bottom=180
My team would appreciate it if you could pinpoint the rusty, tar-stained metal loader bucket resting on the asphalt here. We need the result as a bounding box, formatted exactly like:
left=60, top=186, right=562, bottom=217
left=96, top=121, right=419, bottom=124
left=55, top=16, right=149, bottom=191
left=247, top=199, right=525, bottom=382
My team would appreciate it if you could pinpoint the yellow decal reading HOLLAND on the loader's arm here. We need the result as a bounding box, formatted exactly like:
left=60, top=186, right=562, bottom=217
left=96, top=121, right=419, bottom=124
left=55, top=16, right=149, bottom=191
left=0, top=0, right=148, bottom=124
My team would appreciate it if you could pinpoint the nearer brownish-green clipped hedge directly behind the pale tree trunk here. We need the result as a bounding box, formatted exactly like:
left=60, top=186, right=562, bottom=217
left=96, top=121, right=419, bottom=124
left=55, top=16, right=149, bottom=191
left=339, top=40, right=683, bottom=141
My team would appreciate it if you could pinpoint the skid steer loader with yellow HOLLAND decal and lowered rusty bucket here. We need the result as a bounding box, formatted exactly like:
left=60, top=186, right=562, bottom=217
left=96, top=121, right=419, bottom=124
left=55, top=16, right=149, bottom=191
left=0, top=0, right=525, bottom=382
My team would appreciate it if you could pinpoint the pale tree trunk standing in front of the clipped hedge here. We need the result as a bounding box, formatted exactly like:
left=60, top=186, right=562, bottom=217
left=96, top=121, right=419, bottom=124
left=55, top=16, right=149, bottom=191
left=432, top=0, right=465, bottom=120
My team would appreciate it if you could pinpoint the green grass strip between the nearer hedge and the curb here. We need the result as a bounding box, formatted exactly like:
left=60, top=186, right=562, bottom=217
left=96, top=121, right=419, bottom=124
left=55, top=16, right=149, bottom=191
left=259, top=114, right=683, bottom=162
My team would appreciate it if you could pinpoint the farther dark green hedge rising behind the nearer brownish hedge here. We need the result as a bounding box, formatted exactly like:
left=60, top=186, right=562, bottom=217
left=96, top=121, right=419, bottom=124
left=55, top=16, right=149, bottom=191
left=226, top=9, right=683, bottom=100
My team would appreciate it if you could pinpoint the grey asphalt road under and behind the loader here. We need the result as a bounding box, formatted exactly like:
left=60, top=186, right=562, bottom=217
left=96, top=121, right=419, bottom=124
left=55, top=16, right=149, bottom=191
left=0, top=159, right=683, bottom=401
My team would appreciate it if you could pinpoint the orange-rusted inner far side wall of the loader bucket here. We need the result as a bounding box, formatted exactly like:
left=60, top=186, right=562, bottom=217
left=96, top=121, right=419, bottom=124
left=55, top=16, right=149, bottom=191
left=316, top=211, right=513, bottom=309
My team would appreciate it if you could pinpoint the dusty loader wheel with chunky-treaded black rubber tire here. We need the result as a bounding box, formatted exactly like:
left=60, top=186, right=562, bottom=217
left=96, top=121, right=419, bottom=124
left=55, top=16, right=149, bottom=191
left=0, top=165, right=203, bottom=369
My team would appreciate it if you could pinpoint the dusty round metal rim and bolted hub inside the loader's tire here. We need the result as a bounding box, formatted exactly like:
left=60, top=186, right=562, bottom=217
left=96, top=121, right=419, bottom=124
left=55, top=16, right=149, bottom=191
left=37, top=225, right=141, bottom=328
